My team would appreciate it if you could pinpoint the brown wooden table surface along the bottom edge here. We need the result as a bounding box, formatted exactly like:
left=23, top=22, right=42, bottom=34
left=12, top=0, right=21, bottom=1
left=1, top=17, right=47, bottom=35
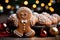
left=0, top=35, right=60, bottom=40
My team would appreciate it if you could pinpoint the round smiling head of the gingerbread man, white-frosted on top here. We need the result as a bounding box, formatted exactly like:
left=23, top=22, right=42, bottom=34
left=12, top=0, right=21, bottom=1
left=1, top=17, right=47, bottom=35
left=16, top=7, right=32, bottom=19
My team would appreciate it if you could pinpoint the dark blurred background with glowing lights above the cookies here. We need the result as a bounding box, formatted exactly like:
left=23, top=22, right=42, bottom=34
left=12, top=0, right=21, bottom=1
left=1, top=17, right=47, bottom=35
left=0, top=0, right=60, bottom=23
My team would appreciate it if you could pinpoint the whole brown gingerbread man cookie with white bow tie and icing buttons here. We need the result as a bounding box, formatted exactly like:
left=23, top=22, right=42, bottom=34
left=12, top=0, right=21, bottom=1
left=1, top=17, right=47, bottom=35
left=14, top=7, right=35, bottom=37
